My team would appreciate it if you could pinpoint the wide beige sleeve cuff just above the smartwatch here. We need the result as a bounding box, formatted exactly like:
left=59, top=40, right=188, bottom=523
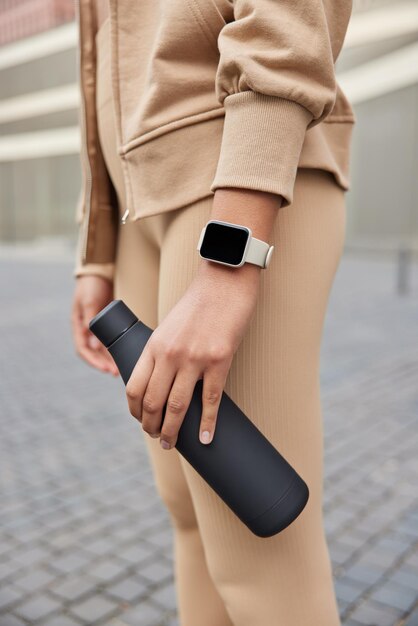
left=210, top=91, right=313, bottom=206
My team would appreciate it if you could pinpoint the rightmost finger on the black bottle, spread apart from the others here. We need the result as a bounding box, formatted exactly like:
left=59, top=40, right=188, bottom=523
left=199, top=364, right=229, bottom=444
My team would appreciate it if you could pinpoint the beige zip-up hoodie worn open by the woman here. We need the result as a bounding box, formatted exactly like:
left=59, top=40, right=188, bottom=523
left=74, top=0, right=355, bottom=277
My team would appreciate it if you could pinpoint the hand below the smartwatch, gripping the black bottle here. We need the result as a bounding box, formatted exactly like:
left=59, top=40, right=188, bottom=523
left=126, top=260, right=261, bottom=449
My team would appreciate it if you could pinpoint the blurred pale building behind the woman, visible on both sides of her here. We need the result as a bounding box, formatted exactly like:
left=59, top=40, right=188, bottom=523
left=0, top=0, right=418, bottom=247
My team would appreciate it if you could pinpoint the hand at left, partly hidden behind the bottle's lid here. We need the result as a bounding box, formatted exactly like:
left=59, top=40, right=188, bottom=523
left=71, top=274, right=119, bottom=376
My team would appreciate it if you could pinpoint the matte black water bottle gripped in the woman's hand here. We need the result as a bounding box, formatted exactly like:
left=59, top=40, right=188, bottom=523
left=89, top=300, right=309, bottom=537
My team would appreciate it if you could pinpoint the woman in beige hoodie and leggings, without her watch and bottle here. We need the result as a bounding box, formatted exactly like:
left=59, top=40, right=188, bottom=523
left=72, top=0, right=354, bottom=626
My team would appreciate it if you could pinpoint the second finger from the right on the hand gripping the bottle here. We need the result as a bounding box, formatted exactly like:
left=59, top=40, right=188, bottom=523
left=160, top=368, right=199, bottom=450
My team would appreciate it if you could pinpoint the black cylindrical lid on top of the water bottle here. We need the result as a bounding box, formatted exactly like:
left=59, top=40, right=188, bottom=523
left=89, top=300, right=138, bottom=348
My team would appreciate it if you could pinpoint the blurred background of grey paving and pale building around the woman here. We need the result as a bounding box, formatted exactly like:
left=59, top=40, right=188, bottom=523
left=0, top=0, right=418, bottom=626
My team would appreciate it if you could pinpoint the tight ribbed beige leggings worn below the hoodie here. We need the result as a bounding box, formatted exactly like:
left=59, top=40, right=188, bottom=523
left=98, top=17, right=345, bottom=626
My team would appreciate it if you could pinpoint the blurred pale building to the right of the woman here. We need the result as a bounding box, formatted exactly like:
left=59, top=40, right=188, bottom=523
left=337, top=0, right=418, bottom=250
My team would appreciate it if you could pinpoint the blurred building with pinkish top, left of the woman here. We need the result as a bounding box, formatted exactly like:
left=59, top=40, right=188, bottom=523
left=0, top=0, right=80, bottom=241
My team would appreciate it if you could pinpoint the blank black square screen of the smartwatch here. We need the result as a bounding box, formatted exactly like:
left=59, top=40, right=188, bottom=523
left=200, top=222, right=250, bottom=265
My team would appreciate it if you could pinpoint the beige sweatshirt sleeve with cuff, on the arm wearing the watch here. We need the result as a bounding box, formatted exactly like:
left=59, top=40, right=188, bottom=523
left=211, top=0, right=352, bottom=206
